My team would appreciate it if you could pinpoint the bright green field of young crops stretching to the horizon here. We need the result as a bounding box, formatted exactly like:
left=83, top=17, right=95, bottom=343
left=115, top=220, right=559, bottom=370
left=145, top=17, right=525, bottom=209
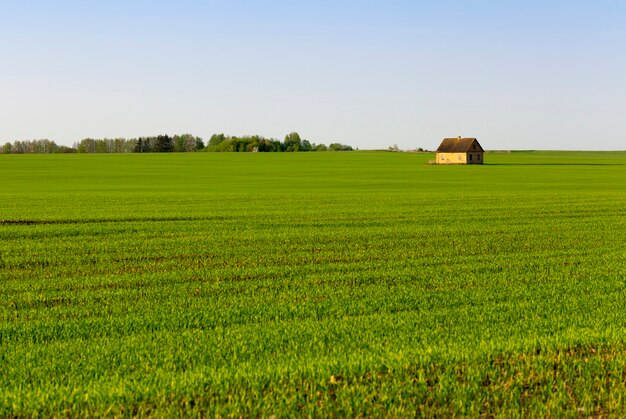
left=0, top=152, right=626, bottom=417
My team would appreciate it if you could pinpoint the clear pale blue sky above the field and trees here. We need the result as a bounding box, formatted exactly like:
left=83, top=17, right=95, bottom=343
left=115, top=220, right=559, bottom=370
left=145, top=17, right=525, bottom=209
left=0, top=0, right=626, bottom=150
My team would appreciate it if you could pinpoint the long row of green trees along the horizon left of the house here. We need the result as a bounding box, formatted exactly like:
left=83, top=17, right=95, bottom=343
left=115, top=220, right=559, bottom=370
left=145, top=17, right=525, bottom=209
left=1, top=132, right=353, bottom=154
